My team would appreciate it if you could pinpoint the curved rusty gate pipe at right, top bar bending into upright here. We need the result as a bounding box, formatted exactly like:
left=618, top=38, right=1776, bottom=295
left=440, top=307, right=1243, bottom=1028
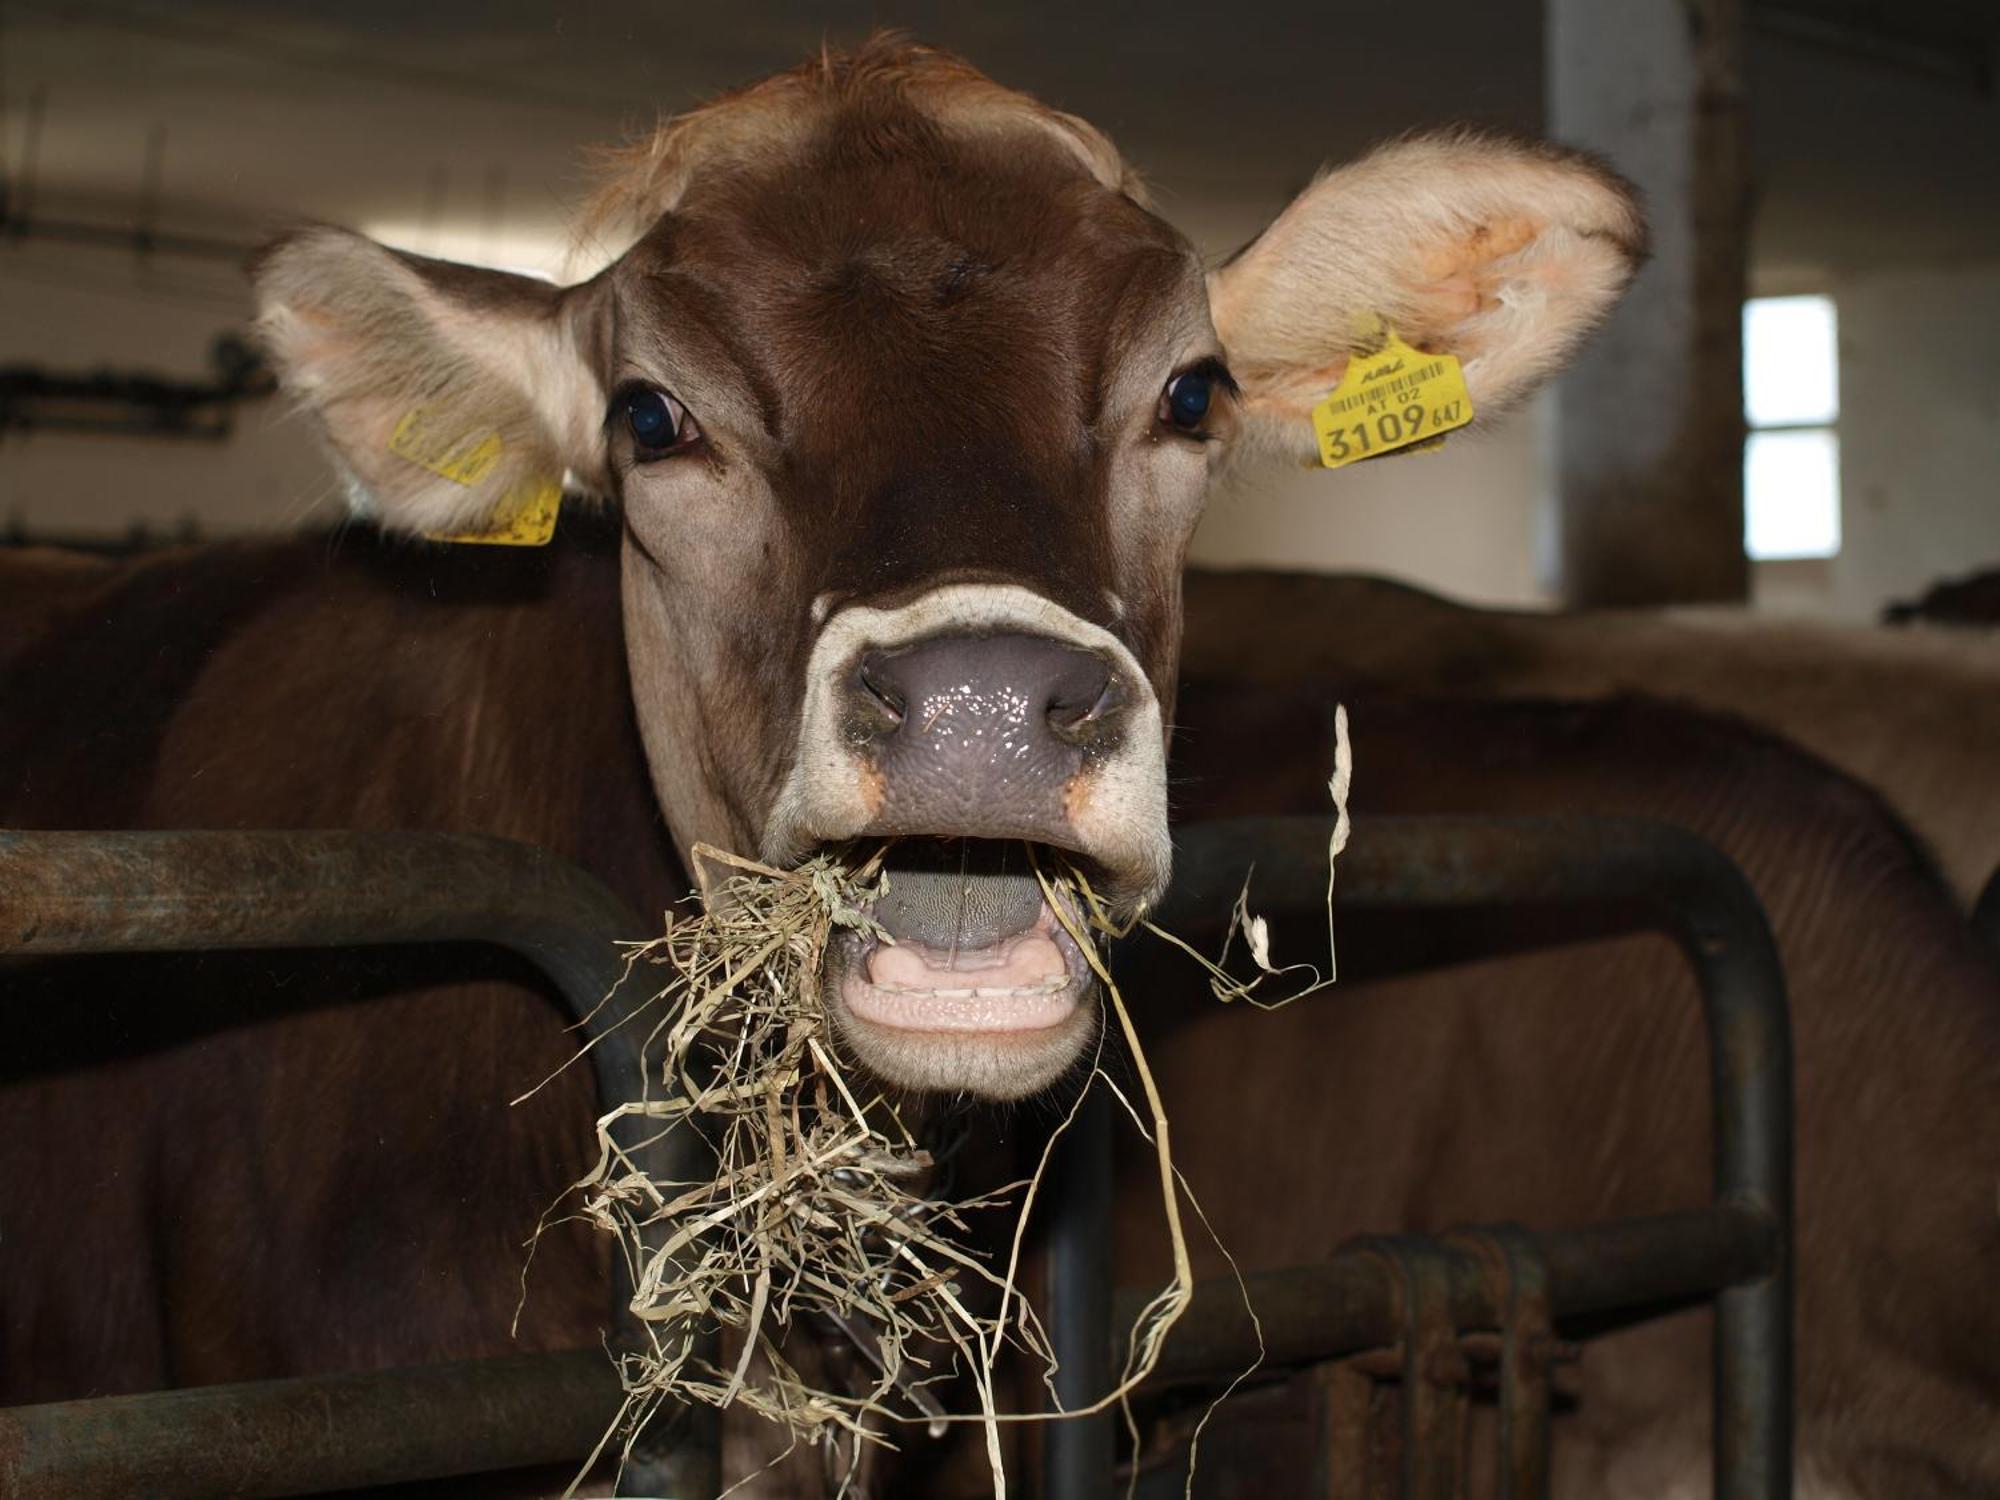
left=1044, top=818, right=1792, bottom=1500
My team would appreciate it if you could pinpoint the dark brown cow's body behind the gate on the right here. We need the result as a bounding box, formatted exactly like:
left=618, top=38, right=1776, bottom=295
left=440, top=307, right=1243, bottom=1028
left=1118, top=684, right=2000, bottom=1500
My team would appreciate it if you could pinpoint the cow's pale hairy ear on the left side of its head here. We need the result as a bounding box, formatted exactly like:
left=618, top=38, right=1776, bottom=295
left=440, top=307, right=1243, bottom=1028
left=252, top=226, right=604, bottom=534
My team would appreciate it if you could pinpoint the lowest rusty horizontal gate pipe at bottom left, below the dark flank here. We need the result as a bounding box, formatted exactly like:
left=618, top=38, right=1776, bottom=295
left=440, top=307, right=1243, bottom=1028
left=0, top=1350, right=620, bottom=1500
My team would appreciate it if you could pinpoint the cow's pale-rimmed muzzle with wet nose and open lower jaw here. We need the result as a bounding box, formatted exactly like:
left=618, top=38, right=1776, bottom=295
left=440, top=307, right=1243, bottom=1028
left=766, top=586, right=1168, bottom=1098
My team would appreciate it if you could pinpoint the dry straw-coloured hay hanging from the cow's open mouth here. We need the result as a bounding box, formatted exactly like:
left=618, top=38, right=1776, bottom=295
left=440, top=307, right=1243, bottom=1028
left=532, top=844, right=1192, bottom=1494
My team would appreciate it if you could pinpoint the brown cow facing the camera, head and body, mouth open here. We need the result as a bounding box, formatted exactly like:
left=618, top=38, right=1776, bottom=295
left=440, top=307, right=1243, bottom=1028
left=0, top=40, right=1644, bottom=1496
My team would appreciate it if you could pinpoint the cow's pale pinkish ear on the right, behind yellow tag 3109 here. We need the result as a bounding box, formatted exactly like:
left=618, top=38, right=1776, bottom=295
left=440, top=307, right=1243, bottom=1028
left=1208, top=134, right=1646, bottom=458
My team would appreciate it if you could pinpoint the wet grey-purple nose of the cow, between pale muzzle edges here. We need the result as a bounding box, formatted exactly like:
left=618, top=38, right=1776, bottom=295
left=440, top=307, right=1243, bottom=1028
left=848, top=634, right=1126, bottom=842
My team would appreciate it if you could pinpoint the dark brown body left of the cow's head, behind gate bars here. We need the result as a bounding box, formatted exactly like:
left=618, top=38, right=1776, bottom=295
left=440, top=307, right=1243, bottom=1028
left=0, top=528, right=684, bottom=1400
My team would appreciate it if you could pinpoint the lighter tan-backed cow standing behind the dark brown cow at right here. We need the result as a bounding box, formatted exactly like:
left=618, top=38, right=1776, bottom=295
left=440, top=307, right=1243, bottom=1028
left=1184, top=570, right=2000, bottom=906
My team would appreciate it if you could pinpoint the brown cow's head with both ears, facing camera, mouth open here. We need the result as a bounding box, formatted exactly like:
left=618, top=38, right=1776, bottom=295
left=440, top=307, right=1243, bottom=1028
left=258, top=44, right=1640, bottom=1096
